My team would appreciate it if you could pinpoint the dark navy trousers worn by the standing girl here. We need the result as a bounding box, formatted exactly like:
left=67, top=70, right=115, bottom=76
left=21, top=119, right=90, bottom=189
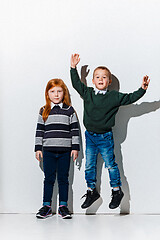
left=43, top=151, right=71, bottom=204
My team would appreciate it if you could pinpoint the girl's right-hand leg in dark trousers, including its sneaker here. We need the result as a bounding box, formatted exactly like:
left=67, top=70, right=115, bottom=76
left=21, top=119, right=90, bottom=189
left=57, top=152, right=71, bottom=219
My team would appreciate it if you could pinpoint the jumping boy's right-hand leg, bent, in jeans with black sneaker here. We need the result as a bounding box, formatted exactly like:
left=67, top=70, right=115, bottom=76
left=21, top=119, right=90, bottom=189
left=98, top=132, right=124, bottom=208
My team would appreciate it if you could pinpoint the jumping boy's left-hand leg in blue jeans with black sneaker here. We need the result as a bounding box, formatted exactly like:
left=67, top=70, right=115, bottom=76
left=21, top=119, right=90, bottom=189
left=81, top=131, right=100, bottom=208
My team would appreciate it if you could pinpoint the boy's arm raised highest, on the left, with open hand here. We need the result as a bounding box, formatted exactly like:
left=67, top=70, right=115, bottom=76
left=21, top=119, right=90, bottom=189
left=70, top=54, right=87, bottom=98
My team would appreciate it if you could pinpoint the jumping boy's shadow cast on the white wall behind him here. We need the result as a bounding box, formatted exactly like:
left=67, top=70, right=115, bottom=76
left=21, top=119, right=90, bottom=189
left=81, top=65, right=160, bottom=214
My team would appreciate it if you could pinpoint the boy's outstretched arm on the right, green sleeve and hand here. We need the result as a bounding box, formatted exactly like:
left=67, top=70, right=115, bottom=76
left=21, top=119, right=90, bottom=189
left=119, top=75, right=150, bottom=106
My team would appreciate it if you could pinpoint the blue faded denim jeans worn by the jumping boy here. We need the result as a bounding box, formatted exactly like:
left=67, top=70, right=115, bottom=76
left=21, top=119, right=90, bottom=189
left=85, top=131, right=121, bottom=189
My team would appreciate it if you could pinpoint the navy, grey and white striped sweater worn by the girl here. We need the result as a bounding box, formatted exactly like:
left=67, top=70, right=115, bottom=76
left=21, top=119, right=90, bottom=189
left=35, top=104, right=80, bottom=152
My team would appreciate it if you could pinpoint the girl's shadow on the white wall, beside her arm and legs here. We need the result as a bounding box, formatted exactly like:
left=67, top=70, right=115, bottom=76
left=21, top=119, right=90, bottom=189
left=39, top=108, right=84, bottom=214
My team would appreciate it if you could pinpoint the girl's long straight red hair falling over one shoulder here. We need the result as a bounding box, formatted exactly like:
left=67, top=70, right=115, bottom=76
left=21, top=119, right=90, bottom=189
left=41, top=78, right=71, bottom=122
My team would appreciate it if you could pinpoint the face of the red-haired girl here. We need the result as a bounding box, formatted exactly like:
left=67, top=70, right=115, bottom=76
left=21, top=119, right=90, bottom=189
left=48, top=87, right=64, bottom=104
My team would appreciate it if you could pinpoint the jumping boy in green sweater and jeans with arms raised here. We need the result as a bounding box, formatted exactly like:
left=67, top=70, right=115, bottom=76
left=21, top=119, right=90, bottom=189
left=71, top=54, right=150, bottom=209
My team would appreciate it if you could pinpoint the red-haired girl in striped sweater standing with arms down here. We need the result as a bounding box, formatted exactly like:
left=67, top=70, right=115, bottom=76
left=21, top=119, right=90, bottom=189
left=35, top=79, right=79, bottom=218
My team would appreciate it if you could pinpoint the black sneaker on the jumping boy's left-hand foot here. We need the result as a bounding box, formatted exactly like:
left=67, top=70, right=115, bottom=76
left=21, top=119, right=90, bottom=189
left=81, top=188, right=100, bottom=208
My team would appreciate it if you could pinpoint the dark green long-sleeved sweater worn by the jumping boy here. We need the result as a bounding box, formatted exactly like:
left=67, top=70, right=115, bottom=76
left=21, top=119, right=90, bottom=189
left=71, top=68, right=146, bottom=133
